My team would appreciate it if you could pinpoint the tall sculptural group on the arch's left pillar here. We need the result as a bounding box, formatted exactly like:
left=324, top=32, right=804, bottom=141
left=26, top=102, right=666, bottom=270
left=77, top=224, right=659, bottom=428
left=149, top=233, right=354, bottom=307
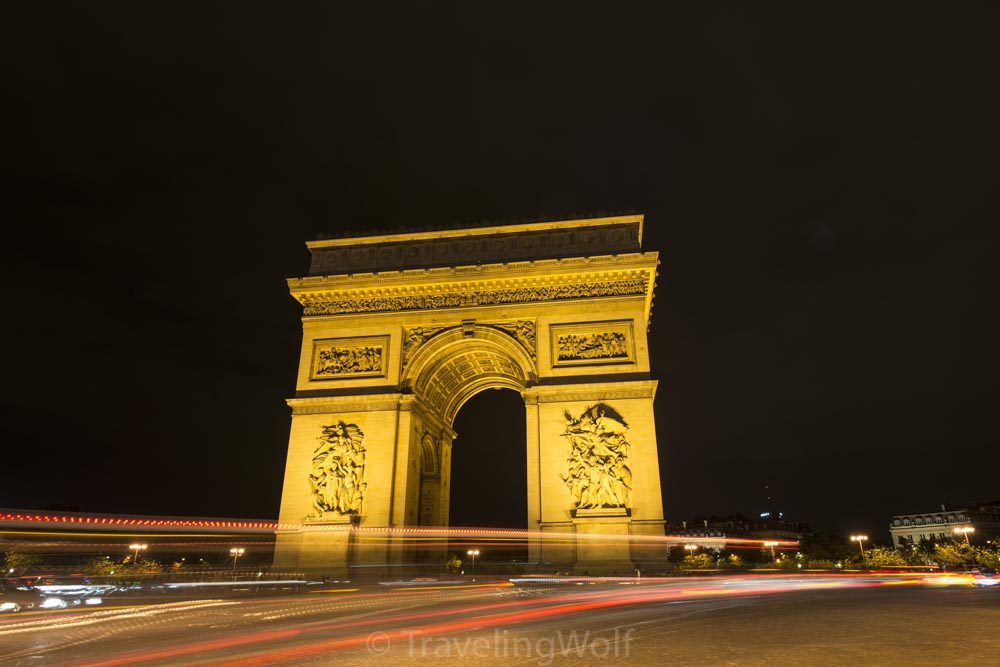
left=308, top=421, right=366, bottom=519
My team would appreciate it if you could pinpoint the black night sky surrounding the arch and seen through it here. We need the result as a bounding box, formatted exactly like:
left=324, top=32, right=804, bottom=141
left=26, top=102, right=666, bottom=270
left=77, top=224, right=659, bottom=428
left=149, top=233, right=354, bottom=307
left=0, top=2, right=1000, bottom=543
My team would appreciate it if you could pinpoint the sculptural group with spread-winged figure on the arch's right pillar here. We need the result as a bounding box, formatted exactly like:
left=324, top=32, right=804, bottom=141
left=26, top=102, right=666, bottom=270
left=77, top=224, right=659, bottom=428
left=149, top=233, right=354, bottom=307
left=562, top=403, right=632, bottom=510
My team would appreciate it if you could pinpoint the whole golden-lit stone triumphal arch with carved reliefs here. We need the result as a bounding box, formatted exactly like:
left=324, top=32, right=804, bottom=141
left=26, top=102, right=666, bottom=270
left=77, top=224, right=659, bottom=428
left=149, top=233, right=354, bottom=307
left=274, top=215, right=666, bottom=578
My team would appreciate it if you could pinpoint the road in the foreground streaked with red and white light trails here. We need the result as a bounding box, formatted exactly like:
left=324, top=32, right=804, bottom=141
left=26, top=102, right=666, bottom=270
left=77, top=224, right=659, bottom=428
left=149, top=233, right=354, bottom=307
left=0, top=577, right=1000, bottom=667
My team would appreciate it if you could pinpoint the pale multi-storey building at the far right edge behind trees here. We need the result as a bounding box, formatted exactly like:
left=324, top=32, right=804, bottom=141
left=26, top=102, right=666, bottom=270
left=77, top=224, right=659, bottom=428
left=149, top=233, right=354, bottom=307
left=889, top=501, right=1000, bottom=547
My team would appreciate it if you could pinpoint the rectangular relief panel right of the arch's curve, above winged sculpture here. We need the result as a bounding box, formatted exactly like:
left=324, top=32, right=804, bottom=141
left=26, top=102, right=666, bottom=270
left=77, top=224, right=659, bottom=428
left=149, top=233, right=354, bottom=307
left=549, top=320, right=635, bottom=366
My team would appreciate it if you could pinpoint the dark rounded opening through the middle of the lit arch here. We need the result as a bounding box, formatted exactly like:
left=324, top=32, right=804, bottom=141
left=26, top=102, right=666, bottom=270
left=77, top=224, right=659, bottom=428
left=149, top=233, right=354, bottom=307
left=449, top=389, right=528, bottom=528
